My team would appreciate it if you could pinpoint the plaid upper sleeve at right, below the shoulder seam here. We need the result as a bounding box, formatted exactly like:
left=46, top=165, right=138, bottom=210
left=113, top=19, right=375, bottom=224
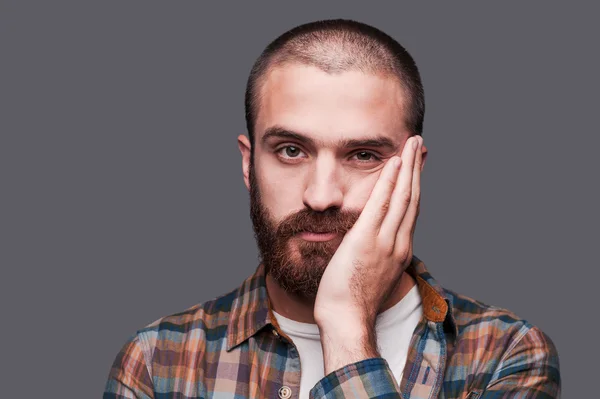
left=472, top=327, right=561, bottom=399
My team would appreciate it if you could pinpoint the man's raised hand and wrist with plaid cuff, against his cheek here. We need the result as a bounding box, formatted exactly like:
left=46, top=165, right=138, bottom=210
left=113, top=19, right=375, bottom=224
left=310, top=137, right=424, bottom=398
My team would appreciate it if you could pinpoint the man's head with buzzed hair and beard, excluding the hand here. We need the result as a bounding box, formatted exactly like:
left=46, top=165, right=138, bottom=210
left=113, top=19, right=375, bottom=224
left=238, top=19, right=424, bottom=302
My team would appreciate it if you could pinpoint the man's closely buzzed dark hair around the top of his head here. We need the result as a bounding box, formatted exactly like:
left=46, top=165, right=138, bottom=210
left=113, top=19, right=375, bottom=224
left=245, top=19, right=425, bottom=153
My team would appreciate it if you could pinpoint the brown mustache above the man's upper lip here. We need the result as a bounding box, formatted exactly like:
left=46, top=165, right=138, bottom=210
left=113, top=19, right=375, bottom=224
left=277, top=208, right=360, bottom=237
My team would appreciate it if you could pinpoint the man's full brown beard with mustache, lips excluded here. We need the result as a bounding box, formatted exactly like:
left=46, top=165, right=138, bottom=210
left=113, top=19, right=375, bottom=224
left=249, top=162, right=360, bottom=300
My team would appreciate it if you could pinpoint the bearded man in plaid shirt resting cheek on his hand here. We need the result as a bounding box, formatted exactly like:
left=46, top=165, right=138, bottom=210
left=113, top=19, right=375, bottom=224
left=104, top=20, right=560, bottom=399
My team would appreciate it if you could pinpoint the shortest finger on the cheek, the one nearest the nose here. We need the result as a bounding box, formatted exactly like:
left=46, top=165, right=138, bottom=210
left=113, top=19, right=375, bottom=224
left=355, top=156, right=402, bottom=232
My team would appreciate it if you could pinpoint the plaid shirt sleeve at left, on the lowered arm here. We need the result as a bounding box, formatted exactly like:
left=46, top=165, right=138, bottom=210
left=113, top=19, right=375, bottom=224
left=103, top=334, right=154, bottom=399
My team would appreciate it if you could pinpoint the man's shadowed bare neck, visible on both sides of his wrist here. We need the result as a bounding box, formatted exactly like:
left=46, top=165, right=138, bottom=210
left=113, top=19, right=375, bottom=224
left=266, top=272, right=416, bottom=324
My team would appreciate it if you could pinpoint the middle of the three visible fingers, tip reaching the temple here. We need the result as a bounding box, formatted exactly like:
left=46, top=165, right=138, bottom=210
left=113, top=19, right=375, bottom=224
left=379, top=136, right=418, bottom=239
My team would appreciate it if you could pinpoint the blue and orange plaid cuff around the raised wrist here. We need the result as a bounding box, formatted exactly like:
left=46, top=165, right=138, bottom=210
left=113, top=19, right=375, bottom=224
left=310, top=357, right=401, bottom=399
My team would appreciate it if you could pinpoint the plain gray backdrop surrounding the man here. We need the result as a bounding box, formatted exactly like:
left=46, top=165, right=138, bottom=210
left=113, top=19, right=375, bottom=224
left=0, top=1, right=600, bottom=397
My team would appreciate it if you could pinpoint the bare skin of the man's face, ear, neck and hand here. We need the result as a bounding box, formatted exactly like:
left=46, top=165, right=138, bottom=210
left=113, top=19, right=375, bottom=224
left=238, top=63, right=427, bottom=374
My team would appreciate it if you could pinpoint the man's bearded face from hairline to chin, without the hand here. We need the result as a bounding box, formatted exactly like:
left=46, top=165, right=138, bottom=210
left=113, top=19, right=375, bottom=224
left=240, top=63, right=409, bottom=299
